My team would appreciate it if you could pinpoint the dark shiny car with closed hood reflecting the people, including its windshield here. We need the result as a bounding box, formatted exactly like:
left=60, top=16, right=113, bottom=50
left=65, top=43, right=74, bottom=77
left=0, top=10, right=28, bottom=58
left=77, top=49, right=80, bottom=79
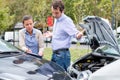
left=0, top=39, right=71, bottom=80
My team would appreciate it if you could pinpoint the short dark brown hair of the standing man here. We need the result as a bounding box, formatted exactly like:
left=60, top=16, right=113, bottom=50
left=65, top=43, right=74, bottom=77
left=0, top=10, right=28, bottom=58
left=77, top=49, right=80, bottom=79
left=51, top=0, right=64, bottom=12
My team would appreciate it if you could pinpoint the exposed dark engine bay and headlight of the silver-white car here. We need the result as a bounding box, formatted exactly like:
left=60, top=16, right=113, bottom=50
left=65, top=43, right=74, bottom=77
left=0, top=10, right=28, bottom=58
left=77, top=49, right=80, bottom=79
left=69, top=54, right=116, bottom=80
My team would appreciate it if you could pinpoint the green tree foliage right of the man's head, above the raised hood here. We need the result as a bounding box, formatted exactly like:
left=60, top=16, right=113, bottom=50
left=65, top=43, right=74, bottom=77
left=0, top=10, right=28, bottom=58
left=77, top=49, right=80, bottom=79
left=64, top=0, right=120, bottom=27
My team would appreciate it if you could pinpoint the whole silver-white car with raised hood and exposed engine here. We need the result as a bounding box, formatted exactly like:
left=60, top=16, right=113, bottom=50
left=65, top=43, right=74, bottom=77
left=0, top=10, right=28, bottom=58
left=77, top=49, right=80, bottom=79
left=68, top=16, right=120, bottom=80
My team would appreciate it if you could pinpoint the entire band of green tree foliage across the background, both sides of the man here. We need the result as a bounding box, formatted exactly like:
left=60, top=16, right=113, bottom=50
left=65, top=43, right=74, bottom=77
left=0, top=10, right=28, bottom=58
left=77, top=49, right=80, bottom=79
left=0, top=0, right=120, bottom=31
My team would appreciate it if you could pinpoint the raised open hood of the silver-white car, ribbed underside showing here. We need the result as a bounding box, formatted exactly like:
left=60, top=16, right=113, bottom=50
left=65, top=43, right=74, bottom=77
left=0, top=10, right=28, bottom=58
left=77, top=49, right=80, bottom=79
left=80, top=16, right=120, bottom=52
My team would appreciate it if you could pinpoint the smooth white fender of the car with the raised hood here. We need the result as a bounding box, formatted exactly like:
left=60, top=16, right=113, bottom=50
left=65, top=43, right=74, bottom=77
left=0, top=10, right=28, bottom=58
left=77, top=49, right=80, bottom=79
left=88, top=59, right=120, bottom=80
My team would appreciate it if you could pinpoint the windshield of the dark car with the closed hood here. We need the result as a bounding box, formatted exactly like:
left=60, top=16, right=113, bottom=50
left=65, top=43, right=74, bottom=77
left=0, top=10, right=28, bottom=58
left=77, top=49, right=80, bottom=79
left=0, top=39, right=20, bottom=52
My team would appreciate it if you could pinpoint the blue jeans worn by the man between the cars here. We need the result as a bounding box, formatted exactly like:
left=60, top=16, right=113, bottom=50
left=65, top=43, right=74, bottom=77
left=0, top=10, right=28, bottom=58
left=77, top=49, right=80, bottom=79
left=52, top=50, right=70, bottom=71
